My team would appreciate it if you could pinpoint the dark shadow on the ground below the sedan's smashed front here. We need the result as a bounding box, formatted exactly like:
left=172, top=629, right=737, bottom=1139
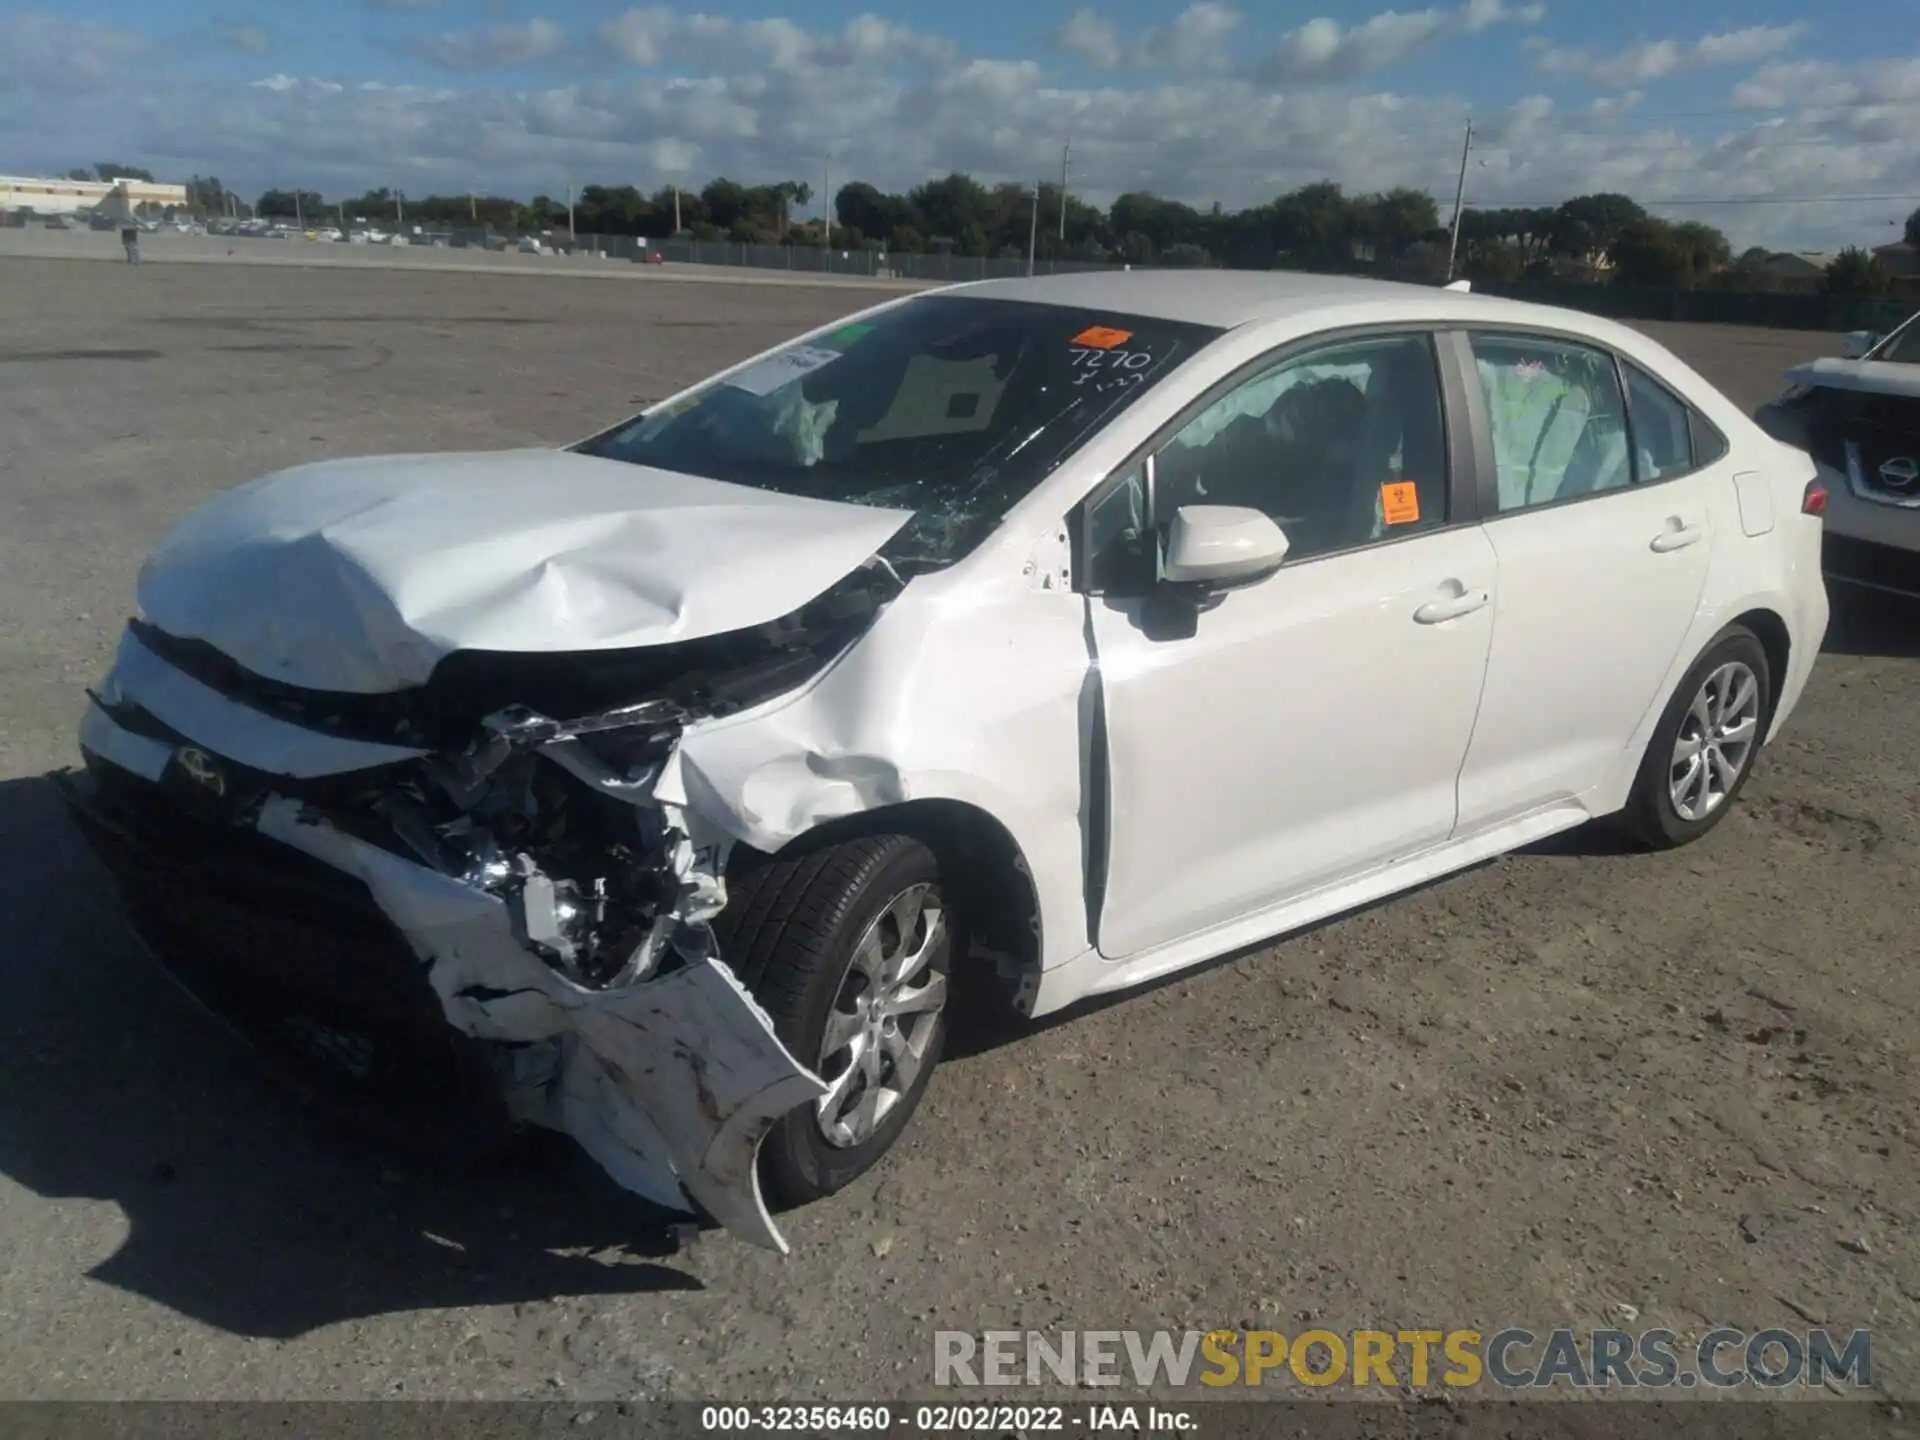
left=0, top=778, right=701, bottom=1338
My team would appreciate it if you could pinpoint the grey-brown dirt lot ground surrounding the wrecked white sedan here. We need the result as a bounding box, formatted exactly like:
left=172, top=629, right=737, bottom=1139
left=0, top=259, right=1920, bottom=1402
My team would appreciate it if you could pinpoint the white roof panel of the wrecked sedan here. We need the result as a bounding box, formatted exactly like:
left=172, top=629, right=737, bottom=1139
left=945, top=269, right=1617, bottom=338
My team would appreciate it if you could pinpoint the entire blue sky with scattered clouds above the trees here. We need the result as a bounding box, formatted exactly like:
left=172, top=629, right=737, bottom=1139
left=0, top=0, right=1920, bottom=246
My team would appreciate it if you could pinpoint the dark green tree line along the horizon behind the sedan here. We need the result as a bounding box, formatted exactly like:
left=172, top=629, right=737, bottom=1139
left=168, top=173, right=1920, bottom=294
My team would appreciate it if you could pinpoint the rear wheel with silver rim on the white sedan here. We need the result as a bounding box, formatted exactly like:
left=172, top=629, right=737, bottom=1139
left=1622, top=626, right=1772, bottom=851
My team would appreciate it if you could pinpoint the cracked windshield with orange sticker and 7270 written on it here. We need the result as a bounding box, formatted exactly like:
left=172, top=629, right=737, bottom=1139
left=580, top=296, right=1217, bottom=564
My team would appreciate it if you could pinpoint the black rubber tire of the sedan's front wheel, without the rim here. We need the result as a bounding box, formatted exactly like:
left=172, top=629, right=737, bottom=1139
left=714, top=835, right=964, bottom=1208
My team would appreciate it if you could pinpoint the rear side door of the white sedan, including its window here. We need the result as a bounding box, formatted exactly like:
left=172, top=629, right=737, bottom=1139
left=1455, top=330, right=1734, bottom=835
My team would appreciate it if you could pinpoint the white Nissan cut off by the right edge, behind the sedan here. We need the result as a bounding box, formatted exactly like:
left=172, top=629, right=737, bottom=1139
left=1755, top=315, right=1920, bottom=597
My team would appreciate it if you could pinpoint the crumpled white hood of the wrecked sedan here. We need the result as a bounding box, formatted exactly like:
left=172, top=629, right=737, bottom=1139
left=138, top=449, right=912, bottom=695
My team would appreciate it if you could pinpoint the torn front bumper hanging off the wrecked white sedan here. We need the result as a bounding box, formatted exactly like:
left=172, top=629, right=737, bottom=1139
left=63, top=687, right=826, bottom=1252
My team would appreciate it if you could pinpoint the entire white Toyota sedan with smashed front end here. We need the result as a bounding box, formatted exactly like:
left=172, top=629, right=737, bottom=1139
left=56, top=273, right=1828, bottom=1248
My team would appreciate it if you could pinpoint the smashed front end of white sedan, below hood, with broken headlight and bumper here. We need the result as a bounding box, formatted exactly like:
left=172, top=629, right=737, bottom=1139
left=67, top=563, right=899, bottom=1252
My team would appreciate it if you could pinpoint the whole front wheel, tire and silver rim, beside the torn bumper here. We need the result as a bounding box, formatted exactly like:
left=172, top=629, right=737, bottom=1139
left=714, top=835, right=956, bottom=1208
